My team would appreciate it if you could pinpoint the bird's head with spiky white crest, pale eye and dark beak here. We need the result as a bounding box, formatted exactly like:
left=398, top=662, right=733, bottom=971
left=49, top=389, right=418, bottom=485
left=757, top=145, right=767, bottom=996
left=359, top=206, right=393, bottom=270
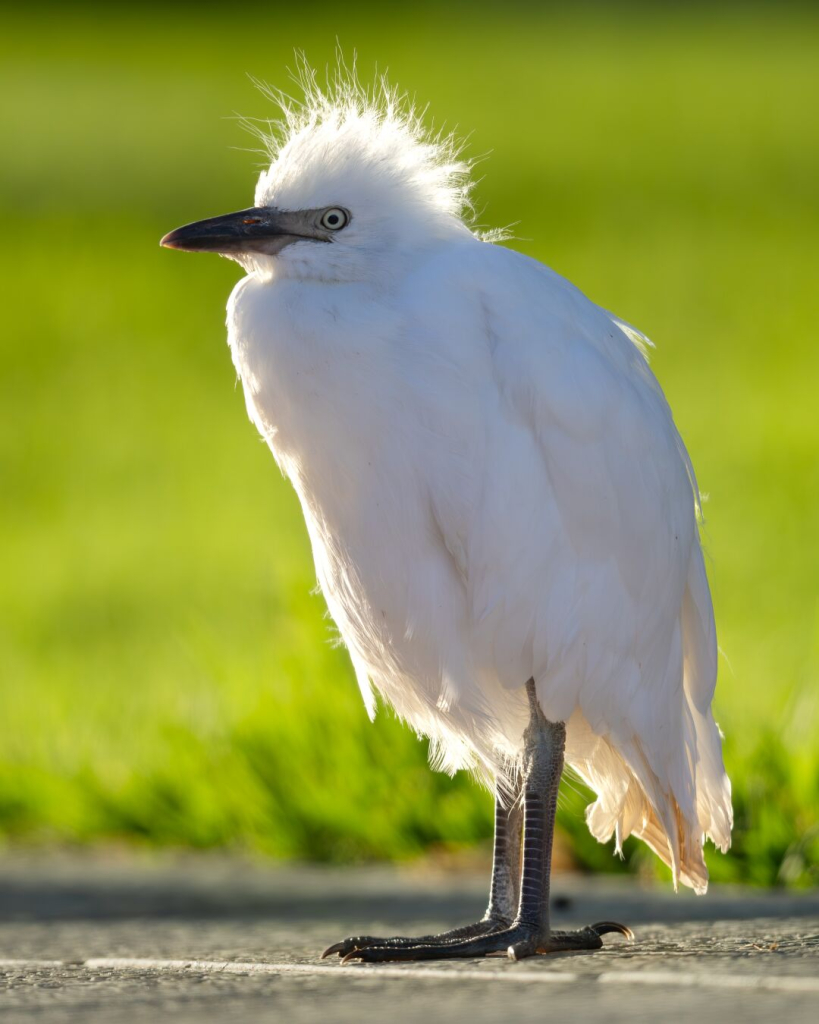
left=161, top=66, right=479, bottom=282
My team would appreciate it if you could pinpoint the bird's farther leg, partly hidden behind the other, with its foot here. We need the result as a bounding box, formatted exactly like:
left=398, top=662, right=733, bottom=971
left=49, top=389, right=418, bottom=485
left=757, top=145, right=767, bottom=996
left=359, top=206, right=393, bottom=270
left=321, top=772, right=523, bottom=957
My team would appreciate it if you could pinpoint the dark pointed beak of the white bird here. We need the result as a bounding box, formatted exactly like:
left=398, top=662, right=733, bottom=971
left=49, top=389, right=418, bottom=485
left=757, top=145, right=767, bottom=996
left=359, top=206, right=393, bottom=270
left=160, top=206, right=310, bottom=256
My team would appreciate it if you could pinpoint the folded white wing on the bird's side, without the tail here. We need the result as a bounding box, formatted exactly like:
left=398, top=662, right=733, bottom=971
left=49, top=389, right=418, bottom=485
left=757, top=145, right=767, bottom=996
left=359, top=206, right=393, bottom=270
left=438, top=247, right=709, bottom=708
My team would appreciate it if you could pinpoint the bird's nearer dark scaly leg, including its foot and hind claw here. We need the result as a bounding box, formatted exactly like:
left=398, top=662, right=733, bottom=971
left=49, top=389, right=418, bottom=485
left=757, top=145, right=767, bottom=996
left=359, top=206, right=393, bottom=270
left=344, top=680, right=632, bottom=963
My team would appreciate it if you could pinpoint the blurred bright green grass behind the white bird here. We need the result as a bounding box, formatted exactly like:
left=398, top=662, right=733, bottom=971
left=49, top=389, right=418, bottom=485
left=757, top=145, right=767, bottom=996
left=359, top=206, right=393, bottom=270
left=0, top=2, right=819, bottom=885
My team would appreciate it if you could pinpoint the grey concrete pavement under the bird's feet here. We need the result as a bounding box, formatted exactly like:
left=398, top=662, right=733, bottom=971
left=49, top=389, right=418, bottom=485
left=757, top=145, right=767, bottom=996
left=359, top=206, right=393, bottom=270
left=0, top=856, right=819, bottom=1024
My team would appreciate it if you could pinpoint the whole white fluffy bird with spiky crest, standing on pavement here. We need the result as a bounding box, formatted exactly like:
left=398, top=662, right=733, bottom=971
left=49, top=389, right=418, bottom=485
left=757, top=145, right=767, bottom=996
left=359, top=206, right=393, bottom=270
left=162, top=66, right=732, bottom=961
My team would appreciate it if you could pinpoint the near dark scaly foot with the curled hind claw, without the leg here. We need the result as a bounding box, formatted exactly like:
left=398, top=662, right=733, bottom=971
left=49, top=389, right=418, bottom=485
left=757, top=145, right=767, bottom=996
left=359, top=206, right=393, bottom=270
left=330, top=921, right=634, bottom=964
